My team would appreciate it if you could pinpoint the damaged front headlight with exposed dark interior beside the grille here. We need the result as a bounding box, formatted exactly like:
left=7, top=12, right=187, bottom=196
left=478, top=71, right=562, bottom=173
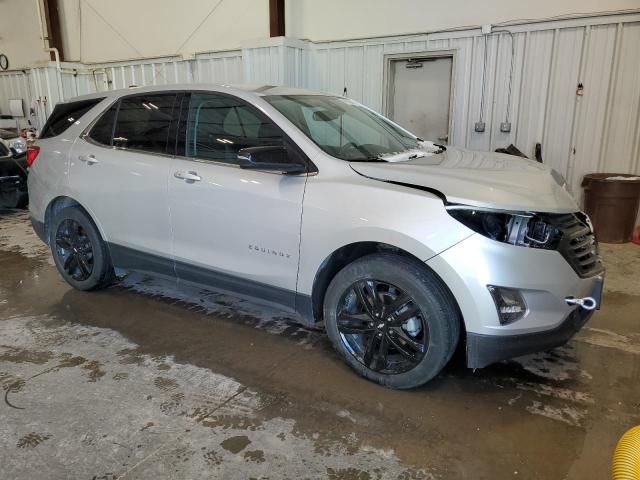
left=447, top=205, right=561, bottom=249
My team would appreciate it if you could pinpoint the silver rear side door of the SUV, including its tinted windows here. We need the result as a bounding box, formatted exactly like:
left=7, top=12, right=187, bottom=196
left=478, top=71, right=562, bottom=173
left=70, top=93, right=181, bottom=274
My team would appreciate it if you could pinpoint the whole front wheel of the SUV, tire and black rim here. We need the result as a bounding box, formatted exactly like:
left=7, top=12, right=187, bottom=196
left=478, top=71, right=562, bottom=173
left=324, top=253, right=460, bottom=389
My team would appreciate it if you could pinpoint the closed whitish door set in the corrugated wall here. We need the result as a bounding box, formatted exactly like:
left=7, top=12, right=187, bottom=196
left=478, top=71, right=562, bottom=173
left=388, top=57, right=453, bottom=143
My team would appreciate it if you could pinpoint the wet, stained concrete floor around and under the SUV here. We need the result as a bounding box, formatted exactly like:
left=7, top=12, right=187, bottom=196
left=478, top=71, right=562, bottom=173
left=0, top=212, right=640, bottom=480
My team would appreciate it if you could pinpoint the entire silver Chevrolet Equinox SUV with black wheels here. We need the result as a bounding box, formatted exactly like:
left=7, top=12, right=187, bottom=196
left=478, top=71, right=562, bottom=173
left=28, top=85, right=603, bottom=388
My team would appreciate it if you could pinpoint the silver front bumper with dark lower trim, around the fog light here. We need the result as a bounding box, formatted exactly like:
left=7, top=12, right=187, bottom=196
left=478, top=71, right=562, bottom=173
left=427, top=234, right=603, bottom=367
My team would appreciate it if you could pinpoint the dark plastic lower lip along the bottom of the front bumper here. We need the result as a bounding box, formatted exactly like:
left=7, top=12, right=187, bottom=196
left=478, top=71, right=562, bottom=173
left=467, top=308, right=593, bottom=368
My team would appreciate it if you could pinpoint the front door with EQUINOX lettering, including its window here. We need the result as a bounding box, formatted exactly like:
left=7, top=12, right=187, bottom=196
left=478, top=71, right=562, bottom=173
left=169, top=93, right=306, bottom=308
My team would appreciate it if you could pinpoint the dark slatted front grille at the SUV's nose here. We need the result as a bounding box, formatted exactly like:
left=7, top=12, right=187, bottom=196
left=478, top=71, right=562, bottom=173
left=548, top=213, right=604, bottom=278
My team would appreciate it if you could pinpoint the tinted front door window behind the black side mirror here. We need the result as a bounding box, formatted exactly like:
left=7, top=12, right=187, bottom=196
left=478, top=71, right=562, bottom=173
left=186, top=93, right=283, bottom=163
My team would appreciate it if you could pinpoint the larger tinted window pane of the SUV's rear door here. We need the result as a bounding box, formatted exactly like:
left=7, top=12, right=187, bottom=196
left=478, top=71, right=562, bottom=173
left=113, top=94, right=176, bottom=153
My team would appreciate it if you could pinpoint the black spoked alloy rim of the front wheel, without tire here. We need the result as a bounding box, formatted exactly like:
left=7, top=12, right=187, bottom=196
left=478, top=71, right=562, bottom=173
left=336, top=279, right=429, bottom=375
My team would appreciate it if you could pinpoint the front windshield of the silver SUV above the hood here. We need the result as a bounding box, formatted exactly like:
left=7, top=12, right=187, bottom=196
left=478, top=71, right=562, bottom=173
left=264, top=95, right=419, bottom=162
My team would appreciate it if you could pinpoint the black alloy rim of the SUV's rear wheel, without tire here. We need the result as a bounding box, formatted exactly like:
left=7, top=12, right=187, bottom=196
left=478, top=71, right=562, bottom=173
left=54, top=219, right=94, bottom=282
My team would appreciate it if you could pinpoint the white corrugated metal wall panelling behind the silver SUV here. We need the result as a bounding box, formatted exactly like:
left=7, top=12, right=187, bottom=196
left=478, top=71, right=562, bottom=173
left=0, top=14, right=640, bottom=202
